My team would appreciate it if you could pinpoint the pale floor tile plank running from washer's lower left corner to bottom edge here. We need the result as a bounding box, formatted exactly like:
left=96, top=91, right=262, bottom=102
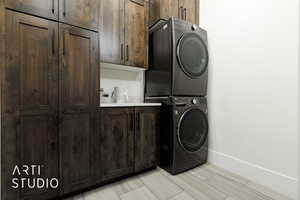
left=141, top=170, right=182, bottom=200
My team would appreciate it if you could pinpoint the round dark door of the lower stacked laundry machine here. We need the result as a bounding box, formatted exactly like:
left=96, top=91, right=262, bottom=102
left=177, top=108, right=208, bottom=152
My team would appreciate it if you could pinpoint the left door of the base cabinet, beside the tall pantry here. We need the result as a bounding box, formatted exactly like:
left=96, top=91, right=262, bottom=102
left=101, top=108, right=134, bottom=181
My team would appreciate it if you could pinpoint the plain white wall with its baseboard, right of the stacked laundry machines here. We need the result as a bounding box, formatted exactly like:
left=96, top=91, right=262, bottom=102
left=200, top=0, right=299, bottom=199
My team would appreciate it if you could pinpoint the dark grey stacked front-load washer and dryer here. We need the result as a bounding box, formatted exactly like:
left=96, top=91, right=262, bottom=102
left=145, top=17, right=208, bottom=174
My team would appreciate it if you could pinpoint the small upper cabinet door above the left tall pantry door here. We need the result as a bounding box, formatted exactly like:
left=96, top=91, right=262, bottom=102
left=5, top=0, right=58, bottom=20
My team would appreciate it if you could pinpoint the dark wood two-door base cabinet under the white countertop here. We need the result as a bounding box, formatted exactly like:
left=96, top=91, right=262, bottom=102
left=100, top=107, right=160, bottom=181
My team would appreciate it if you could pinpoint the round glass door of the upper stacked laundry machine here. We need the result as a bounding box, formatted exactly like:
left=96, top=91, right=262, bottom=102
left=177, top=32, right=208, bottom=78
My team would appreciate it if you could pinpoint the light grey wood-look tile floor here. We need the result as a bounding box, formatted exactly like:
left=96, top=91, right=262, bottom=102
left=67, top=164, right=291, bottom=200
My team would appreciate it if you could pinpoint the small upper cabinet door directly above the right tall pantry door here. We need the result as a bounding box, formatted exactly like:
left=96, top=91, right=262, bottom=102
left=59, top=0, right=100, bottom=31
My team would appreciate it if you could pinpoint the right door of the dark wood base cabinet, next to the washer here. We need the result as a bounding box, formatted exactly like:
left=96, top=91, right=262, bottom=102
left=135, top=107, right=160, bottom=171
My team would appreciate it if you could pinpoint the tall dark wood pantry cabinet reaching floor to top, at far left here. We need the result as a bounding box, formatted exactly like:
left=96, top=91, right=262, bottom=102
left=0, top=0, right=100, bottom=200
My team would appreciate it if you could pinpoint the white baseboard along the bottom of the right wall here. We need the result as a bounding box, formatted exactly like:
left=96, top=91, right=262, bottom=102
left=208, top=150, right=298, bottom=200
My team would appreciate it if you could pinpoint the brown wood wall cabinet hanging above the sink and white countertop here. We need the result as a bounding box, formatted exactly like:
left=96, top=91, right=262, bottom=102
left=100, top=0, right=149, bottom=68
